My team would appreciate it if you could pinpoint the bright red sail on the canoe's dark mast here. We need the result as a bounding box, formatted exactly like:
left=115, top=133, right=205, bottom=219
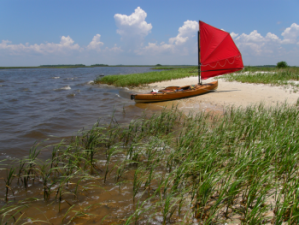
left=199, top=21, right=244, bottom=79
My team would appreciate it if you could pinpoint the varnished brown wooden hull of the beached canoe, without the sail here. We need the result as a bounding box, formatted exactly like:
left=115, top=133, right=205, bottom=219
left=131, top=81, right=218, bottom=103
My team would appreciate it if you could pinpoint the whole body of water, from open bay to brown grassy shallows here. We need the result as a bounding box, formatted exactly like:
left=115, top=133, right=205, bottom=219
left=0, top=67, right=223, bottom=224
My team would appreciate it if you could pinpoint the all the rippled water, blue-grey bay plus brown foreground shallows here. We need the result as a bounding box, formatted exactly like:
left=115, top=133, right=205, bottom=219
left=0, top=67, right=218, bottom=225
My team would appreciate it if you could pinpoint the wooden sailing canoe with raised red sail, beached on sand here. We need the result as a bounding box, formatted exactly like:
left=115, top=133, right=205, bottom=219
left=131, top=21, right=244, bottom=102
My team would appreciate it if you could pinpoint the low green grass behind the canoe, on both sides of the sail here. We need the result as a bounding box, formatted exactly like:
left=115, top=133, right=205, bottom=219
left=95, top=66, right=299, bottom=88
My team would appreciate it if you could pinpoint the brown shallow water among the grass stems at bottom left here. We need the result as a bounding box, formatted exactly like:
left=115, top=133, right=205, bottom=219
left=0, top=151, right=192, bottom=225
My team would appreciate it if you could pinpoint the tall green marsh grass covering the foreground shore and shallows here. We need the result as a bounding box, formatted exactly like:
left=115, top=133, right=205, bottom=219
left=0, top=105, right=299, bottom=224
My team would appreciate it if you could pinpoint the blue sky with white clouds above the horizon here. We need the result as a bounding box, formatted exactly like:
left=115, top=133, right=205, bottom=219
left=0, top=0, right=299, bottom=66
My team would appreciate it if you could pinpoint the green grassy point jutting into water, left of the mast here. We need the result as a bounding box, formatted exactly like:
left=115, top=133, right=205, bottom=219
left=94, top=67, right=197, bottom=87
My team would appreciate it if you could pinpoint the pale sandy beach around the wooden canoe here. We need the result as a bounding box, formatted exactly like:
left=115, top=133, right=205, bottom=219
left=133, top=77, right=299, bottom=111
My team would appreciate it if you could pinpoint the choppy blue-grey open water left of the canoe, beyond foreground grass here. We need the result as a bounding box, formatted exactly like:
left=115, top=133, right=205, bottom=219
left=0, top=67, right=157, bottom=159
